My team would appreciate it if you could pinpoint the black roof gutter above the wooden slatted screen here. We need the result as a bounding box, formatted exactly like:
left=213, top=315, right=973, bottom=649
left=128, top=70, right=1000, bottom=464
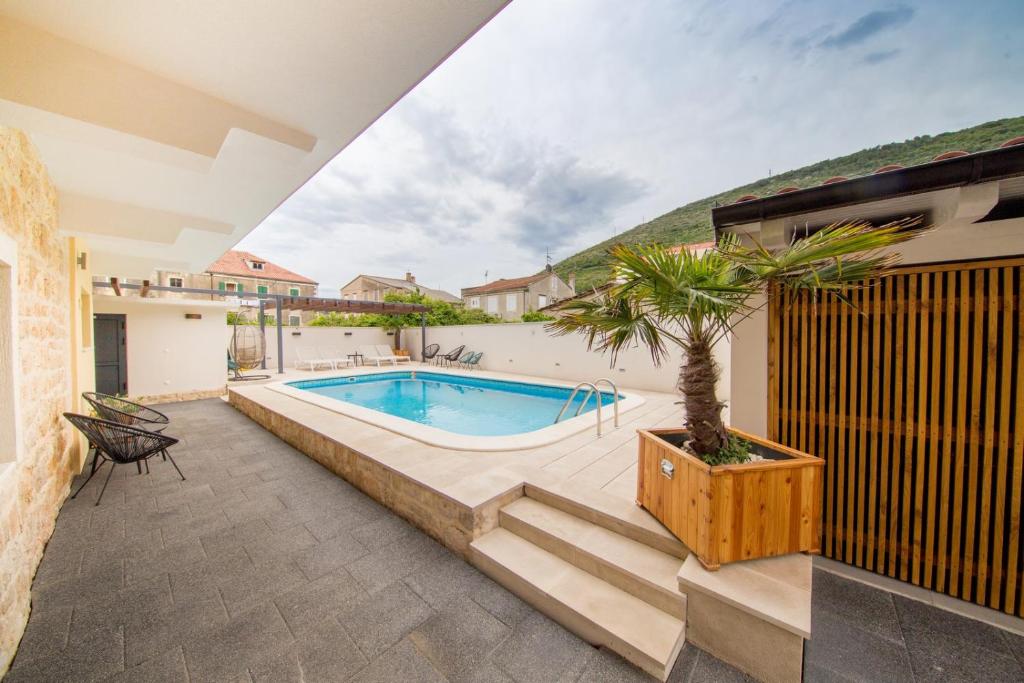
left=711, top=144, right=1024, bottom=239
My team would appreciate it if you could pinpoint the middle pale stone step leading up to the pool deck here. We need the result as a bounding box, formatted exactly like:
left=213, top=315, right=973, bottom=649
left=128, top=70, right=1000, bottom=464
left=499, top=498, right=686, bottom=620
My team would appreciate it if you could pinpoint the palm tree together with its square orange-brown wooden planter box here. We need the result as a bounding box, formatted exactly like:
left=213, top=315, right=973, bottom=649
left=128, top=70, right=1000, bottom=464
left=547, top=220, right=921, bottom=569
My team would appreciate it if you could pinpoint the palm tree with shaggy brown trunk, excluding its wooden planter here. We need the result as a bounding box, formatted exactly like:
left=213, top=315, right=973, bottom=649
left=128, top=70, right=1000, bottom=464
left=547, top=219, right=922, bottom=463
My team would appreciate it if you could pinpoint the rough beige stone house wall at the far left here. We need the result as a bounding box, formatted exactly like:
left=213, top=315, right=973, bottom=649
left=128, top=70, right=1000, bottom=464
left=0, top=126, right=77, bottom=676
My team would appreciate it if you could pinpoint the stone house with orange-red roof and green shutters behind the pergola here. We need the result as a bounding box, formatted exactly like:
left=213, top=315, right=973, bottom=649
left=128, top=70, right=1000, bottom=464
left=156, top=250, right=318, bottom=325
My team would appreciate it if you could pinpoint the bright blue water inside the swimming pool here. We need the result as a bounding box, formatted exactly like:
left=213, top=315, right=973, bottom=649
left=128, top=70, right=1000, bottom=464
left=288, top=371, right=612, bottom=436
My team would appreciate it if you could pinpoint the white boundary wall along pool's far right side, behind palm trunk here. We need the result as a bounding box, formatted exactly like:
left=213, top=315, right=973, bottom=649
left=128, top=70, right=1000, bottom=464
left=403, top=323, right=730, bottom=401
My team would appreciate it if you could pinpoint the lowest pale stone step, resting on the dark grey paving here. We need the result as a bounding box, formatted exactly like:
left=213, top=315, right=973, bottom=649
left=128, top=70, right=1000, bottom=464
left=470, top=527, right=685, bottom=681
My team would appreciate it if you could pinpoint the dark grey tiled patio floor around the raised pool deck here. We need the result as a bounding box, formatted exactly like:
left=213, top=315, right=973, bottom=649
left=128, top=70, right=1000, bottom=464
left=5, top=399, right=1024, bottom=683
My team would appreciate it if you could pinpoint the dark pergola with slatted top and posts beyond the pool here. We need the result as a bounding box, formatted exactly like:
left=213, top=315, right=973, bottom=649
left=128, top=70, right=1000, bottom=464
left=93, top=278, right=430, bottom=375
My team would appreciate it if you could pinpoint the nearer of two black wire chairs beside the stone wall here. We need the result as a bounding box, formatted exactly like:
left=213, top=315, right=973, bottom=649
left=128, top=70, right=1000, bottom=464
left=63, top=413, right=185, bottom=505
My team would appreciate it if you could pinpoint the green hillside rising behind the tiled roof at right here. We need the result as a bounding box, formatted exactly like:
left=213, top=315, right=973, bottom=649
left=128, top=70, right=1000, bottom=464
left=555, top=117, right=1024, bottom=290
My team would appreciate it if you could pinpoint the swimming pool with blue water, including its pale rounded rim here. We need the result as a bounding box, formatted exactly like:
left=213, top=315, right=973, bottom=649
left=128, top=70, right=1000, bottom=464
left=268, top=369, right=643, bottom=451
